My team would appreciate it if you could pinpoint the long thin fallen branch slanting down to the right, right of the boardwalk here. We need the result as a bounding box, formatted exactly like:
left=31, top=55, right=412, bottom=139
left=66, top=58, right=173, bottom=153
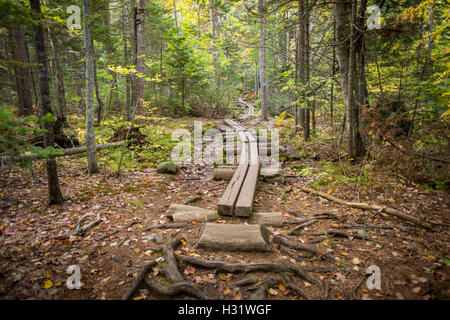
left=299, top=186, right=432, bottom=230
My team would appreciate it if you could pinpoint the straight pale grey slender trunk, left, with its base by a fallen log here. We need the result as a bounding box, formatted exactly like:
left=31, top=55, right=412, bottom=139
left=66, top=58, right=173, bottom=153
left=83, top=0, right=100, bottom=174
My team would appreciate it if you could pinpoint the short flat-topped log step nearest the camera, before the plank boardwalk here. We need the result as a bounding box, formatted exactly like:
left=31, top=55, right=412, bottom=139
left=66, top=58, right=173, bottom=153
left=196, top=223, right=270, bottom=251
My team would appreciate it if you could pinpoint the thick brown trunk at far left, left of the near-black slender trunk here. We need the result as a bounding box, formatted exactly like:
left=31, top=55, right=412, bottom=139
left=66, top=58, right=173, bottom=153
left=10, top=29, right=33, bottom=116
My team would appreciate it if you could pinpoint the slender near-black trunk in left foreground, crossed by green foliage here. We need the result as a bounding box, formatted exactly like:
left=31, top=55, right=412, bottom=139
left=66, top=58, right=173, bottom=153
left=30, top=0, right=64, bottom=204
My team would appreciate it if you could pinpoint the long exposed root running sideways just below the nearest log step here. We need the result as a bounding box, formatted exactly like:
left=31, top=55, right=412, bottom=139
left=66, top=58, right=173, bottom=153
left=179, top=256, right=320, bottom=287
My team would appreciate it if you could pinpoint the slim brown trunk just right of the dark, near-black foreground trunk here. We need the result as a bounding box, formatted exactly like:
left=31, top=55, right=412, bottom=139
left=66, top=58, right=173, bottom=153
left=48, top=28, right=67, bottom=125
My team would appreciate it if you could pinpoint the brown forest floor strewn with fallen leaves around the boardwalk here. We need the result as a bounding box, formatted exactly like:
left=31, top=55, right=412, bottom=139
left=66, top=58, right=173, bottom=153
left=0, top=115, right=450, bottom=300
